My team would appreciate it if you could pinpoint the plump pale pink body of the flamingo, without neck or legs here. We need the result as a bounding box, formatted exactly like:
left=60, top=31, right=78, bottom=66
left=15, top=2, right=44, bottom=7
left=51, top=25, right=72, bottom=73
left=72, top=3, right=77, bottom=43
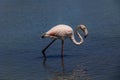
left=45, top=24, right=73, bottom=40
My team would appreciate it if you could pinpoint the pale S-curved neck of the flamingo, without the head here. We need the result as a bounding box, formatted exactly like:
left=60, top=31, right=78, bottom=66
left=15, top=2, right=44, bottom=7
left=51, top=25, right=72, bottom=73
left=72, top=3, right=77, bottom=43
left=71, top=27, right=83, bottom=45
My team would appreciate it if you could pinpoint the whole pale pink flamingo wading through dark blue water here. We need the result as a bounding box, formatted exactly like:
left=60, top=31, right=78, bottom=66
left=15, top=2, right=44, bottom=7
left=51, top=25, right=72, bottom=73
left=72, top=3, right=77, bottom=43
left=41, top=24, right=88, bottom=57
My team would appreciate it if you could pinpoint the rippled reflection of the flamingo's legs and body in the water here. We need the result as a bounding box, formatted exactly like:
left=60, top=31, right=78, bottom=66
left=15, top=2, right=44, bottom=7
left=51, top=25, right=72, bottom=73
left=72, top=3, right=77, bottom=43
left=43, top=54, right=91, bottom=80
